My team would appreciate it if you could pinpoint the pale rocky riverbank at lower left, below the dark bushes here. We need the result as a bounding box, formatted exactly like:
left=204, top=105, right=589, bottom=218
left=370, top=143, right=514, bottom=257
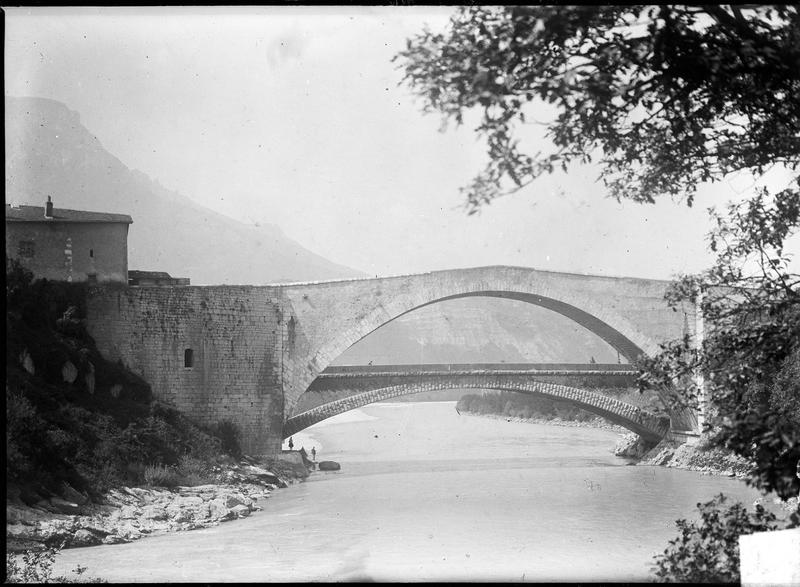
left=6, top=461, right=308, bottom=552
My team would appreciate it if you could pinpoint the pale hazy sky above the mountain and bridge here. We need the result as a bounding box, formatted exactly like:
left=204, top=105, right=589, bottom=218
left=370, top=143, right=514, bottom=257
left=5, top=7, right=797, bottom=278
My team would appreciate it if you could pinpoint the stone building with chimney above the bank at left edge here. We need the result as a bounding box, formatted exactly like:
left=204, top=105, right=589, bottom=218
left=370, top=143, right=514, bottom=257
left=6, top=196, right=133, bottom=284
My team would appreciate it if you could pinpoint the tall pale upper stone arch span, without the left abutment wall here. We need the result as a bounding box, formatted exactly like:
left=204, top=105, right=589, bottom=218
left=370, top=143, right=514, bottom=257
left=284, top=267, right=694, bottom=429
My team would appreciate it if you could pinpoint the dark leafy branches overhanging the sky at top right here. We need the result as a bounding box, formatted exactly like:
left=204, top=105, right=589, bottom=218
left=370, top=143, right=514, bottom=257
left=395, top=5, right=800, bottom=213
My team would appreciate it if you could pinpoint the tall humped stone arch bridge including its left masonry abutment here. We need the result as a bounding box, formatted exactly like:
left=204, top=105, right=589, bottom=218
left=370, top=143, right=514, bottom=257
left=87, top=266, right=697, bottom=453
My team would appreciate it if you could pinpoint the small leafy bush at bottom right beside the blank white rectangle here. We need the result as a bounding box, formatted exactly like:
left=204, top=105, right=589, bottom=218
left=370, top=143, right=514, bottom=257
left=654, top=494, right=777, bottom=583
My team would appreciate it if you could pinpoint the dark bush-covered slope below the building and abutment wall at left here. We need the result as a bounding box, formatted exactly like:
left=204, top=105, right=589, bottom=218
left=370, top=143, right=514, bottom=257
left=6, top=258, right=241, bottom=505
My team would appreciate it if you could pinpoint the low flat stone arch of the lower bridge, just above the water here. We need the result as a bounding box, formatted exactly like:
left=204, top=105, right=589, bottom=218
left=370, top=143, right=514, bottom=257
left=283, top=381, right=670, bottom=443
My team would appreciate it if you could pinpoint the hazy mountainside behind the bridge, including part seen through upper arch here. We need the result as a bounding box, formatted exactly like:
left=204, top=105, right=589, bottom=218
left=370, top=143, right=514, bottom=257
left=5, top=97, right=617, bottom=364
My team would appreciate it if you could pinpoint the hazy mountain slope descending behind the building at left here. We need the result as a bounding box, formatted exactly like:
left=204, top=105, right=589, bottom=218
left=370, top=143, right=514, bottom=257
left=5, top=97, right=362, bottom=285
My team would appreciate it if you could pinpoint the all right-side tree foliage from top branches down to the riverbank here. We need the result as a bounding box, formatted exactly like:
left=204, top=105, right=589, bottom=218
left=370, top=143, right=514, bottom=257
left=395, top=5, right=800, bottom=497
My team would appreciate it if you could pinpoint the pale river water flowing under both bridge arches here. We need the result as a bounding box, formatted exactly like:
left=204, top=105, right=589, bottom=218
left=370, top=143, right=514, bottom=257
left=57, top=402, right=772, bottom=582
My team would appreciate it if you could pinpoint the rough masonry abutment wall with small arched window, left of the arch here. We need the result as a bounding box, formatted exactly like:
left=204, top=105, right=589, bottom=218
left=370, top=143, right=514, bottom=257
left=88, top=286, right=287, bottom=454
